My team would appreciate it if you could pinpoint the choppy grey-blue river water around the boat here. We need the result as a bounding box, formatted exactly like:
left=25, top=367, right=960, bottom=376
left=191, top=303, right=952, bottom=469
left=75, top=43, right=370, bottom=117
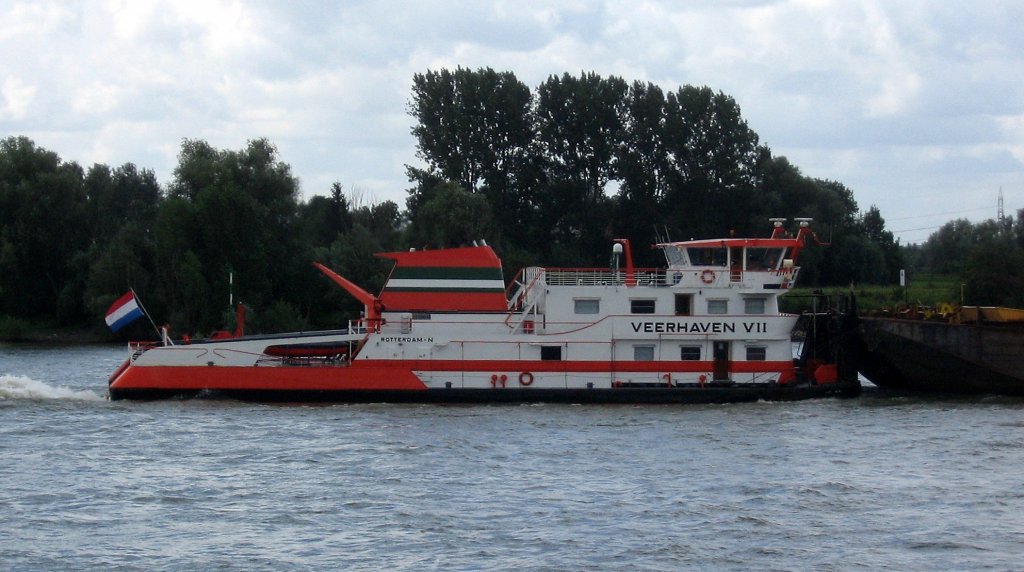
left=0, top=346, right=1024, bottom=571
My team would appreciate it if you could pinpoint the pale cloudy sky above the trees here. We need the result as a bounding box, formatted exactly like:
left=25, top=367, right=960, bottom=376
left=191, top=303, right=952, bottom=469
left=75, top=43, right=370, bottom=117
left=0, top=0, right=1024, bottom=243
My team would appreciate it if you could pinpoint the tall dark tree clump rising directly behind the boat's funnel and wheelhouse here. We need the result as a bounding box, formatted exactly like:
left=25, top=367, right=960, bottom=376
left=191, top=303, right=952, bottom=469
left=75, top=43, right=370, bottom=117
left=407, top=68, right=901, bottom=283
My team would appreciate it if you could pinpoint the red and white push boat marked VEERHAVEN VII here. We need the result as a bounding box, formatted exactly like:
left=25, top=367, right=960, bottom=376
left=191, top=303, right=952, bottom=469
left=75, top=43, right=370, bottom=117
left=109, top=219, right=860, bottom=403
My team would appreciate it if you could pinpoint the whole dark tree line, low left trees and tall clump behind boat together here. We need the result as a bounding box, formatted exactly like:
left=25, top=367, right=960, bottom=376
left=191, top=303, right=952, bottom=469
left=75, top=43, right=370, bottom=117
left=0, top=68, right=903, bottom=336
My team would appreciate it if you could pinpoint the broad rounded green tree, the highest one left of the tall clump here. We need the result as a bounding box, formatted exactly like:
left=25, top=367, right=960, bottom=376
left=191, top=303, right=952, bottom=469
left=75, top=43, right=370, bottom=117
left=157, top=139, right=301, bottom=332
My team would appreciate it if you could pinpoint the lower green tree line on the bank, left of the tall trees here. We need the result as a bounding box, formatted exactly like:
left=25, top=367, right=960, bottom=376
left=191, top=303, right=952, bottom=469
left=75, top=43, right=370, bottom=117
left=0, top=137, right=402, bottom=338
